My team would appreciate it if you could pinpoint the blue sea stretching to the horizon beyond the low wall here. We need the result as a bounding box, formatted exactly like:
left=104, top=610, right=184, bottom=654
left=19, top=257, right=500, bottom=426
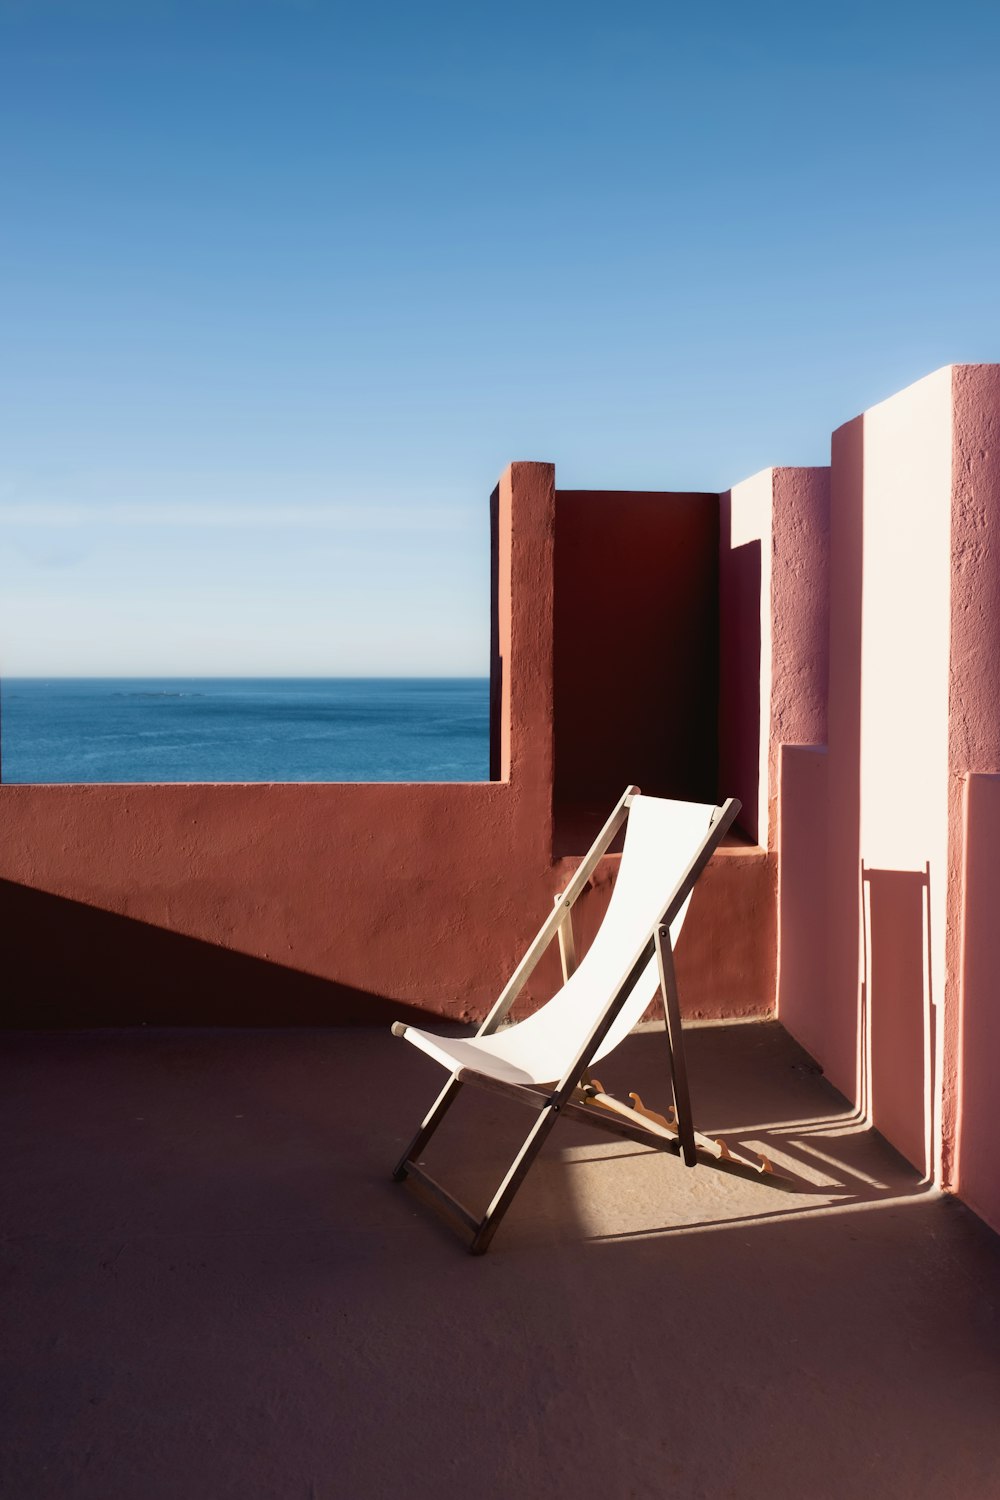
left=0, top=678, right=489, bottom=783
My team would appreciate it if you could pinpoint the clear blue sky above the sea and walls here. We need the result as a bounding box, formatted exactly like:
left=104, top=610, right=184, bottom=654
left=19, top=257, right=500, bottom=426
left=0, top=0, right=1000, bottom=675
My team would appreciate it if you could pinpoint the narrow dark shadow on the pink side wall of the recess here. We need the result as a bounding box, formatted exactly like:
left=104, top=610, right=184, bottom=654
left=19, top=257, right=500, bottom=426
left=718, top=494, right=768, bottom=843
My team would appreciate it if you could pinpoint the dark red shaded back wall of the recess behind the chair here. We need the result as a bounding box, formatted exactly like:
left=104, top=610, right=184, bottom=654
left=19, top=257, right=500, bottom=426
left=553, top=491, right=718, bottom=854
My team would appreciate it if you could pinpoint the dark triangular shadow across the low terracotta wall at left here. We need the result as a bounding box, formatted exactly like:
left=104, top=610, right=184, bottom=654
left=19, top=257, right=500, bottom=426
left=0, top=881, right=429, bottom=1028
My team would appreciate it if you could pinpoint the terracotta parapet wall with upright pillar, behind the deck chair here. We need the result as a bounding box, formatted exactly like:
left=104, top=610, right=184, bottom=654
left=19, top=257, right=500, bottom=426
left=0, top=464, right=774, bottom=1026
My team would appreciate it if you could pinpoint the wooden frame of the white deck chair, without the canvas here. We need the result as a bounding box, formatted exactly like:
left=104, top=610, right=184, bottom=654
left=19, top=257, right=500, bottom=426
left=393, top=786, right=796, bottom=1256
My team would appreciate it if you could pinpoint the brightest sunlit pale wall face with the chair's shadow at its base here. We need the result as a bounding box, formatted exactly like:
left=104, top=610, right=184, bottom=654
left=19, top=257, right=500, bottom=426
left=861, top=369, right=952, bottom=1172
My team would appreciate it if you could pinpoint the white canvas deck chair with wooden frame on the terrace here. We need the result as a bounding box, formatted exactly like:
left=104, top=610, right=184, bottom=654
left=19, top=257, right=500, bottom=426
left=393, top=786, right=796, bottom=1254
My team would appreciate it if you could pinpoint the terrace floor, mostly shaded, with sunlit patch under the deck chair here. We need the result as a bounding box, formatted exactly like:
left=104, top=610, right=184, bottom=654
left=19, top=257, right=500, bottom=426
left=0, top=1023, right=1000, bottom=1500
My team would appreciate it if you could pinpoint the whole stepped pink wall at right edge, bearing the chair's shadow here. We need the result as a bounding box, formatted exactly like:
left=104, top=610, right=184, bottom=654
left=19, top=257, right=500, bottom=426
left=778, top=366, right=1000, bottom=1227
